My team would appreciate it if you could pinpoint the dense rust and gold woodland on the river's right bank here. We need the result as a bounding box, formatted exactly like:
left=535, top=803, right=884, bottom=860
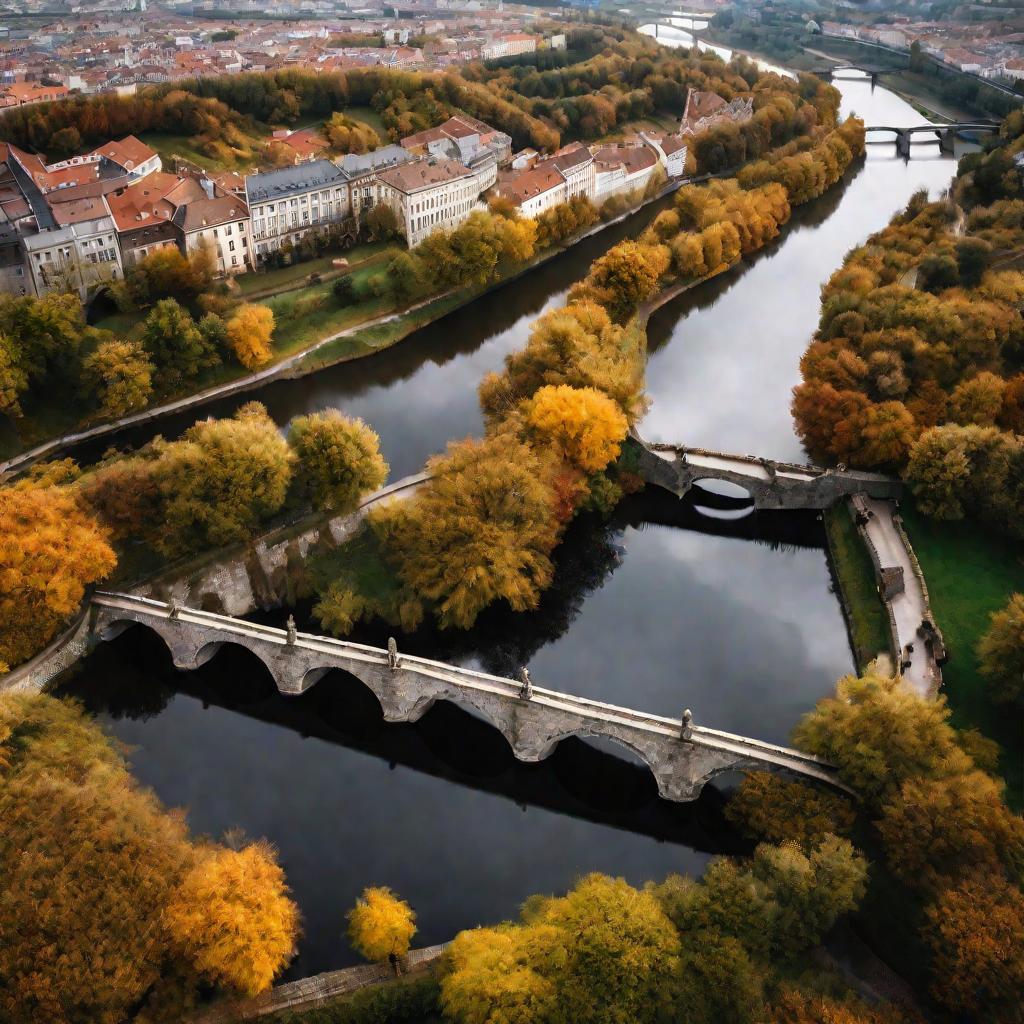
left=793, top=113, right=1024, bottom=537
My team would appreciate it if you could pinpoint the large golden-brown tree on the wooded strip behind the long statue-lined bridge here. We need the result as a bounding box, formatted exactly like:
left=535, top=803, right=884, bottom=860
left=378, top=437, right=558, bottom=629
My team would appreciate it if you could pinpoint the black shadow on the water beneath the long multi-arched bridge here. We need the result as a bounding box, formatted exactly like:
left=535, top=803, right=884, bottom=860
left=59, top=627, right=746, bottom=853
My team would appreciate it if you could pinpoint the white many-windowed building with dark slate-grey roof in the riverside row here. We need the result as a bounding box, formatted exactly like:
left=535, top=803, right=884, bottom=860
left=246, top=160, right=350, bottom=263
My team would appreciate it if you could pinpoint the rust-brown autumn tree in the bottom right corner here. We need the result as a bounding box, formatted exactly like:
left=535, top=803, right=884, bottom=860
left=924, top=877, right=1024, bottom=1024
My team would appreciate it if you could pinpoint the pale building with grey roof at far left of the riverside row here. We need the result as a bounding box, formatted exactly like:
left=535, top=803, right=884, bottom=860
left=24, top=217, right=124, bottom=302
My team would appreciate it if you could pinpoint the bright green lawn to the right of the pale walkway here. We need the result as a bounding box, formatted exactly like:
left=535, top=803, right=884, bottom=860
left=903, top=507, right=1024, bottom=808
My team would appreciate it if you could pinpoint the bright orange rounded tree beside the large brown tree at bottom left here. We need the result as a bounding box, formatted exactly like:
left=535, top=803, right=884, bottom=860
left=164, top=842, right=299, bottom=996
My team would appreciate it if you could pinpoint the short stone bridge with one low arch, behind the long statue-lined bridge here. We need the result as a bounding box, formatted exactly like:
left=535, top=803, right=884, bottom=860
left=631, top=434, right=903, bottom=509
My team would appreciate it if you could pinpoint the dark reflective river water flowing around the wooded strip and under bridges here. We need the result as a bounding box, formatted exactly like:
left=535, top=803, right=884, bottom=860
left=58, top=74, right=954, bottom=977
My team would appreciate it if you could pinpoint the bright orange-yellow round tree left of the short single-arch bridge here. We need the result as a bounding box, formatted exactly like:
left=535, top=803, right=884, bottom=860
left=526, top=384, right=629, bottom=473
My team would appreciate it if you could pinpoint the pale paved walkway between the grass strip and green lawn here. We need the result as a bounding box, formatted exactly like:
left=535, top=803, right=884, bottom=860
left=863, top=496, right=936, bottom=697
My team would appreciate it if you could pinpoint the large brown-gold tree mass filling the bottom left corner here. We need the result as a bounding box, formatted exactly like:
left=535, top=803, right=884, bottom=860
left=0, top=692, right=191, bottom=1024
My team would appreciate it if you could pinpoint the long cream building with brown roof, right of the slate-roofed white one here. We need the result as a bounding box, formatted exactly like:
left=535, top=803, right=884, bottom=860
left=377, top=159, right=497, bottom=249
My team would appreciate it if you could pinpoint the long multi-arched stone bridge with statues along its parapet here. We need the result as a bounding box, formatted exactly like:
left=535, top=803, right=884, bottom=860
left=90, top=592, right=851, bottom=802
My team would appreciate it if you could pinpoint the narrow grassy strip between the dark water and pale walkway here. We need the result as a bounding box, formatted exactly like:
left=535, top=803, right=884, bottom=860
left=825, top=503, right=891, bottom=672
